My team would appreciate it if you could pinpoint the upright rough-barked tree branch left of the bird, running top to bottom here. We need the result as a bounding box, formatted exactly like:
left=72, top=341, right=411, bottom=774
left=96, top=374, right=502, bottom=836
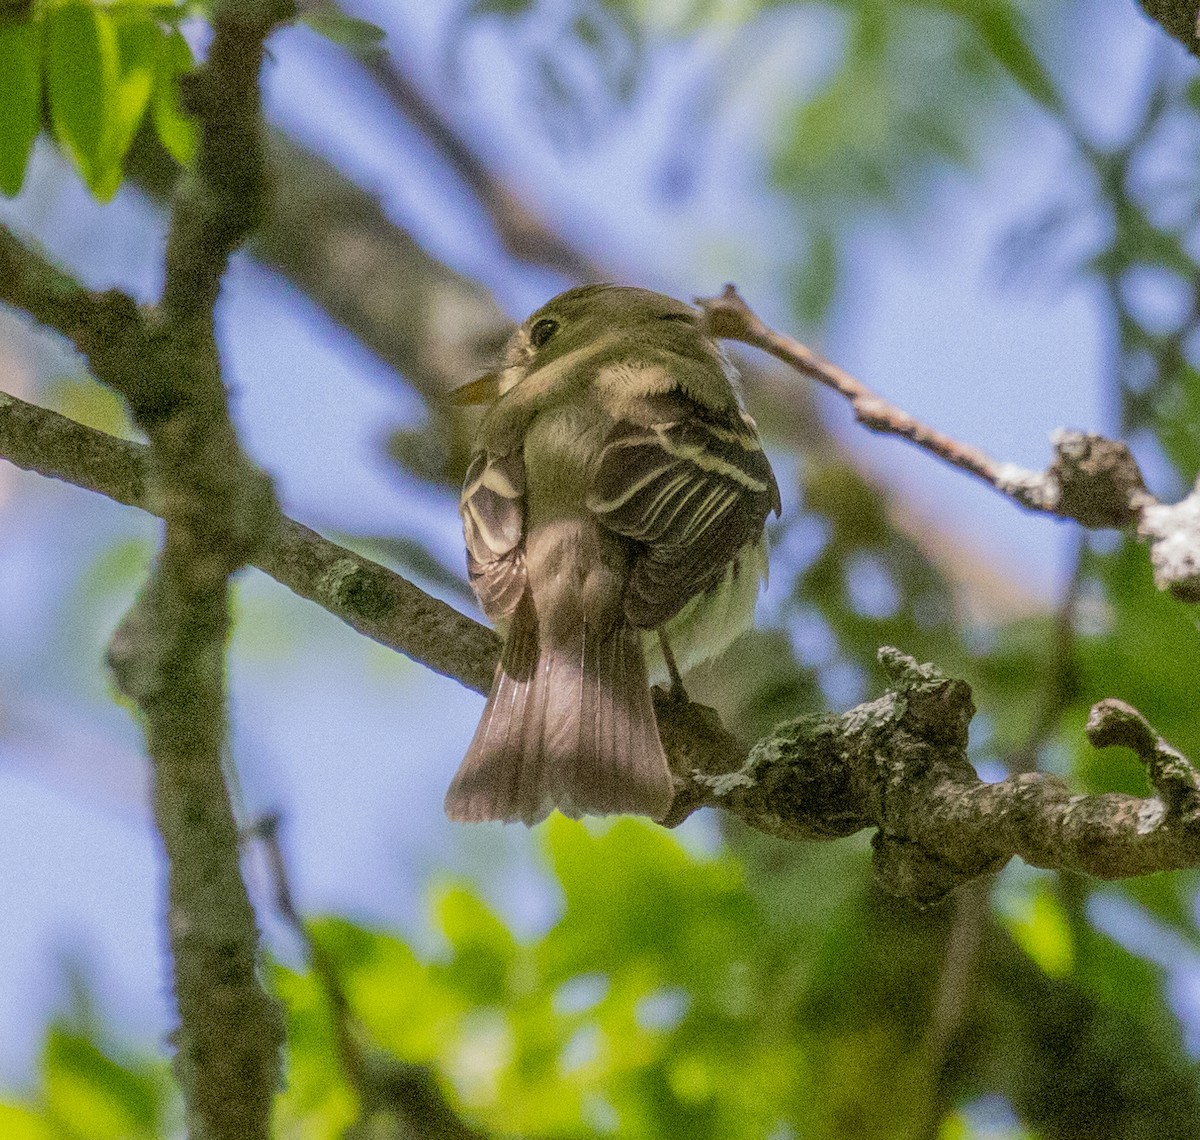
left=95, top=0, right=289, bottom=1140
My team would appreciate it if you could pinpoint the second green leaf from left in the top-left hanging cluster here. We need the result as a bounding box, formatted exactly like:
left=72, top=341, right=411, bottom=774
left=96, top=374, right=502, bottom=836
left=46, top=2, right=120, bottom=197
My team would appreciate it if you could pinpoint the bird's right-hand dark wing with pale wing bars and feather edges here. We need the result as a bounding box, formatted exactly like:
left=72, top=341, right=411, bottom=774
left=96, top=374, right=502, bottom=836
left=587, top=414, right=780, bottom=629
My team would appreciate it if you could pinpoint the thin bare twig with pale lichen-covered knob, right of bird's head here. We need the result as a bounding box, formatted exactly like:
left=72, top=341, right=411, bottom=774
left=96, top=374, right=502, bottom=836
left=697, top=286, right=1200, bottom=602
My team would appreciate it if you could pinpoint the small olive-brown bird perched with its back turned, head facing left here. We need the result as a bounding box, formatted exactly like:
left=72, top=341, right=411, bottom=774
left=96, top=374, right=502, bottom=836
left=445, top=284, right=780, bottom=824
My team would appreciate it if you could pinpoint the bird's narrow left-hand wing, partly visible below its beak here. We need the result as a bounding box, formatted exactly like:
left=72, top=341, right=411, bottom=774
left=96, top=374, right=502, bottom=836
left=458, top=451, right=526, bottom=622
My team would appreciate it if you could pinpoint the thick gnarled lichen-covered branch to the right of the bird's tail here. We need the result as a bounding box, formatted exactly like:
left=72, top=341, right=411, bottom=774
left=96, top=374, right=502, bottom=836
left=659, top=649, right=1200, bottom=904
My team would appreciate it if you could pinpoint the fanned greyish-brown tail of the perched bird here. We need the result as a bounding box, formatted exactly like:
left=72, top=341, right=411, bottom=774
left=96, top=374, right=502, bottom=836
left=445, top=592, right=673, bottom=824
